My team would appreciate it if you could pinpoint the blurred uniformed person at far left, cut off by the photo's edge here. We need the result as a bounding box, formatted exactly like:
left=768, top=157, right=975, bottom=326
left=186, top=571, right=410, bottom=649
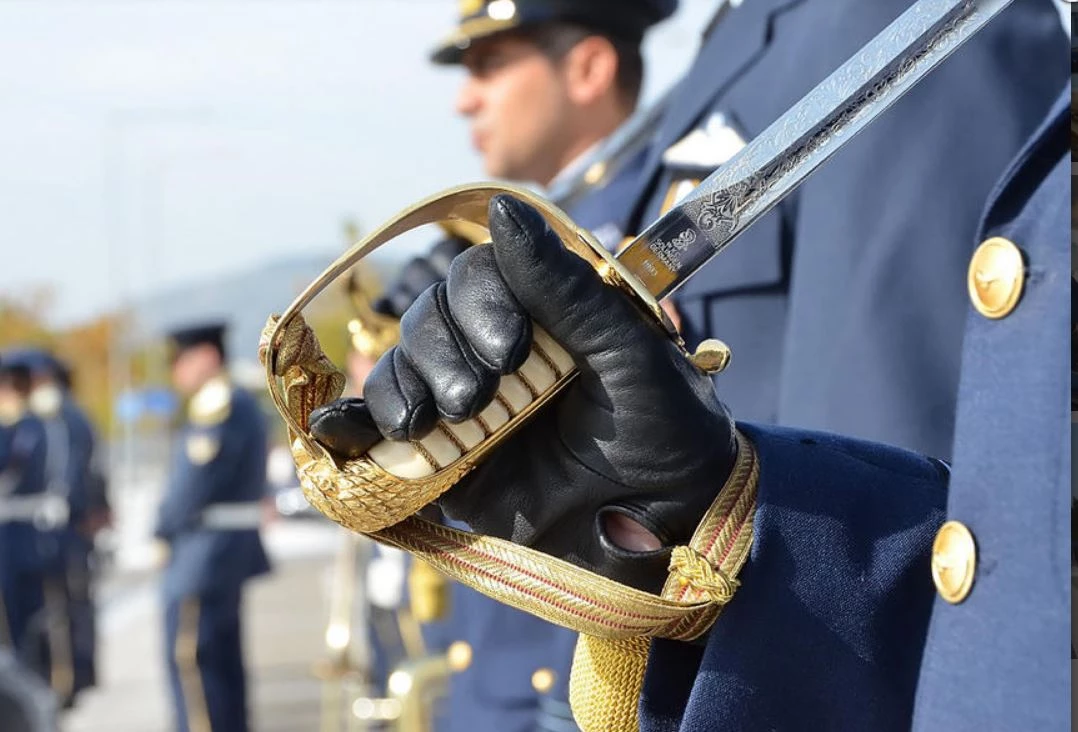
left=0, top=354, right=52, bottom=681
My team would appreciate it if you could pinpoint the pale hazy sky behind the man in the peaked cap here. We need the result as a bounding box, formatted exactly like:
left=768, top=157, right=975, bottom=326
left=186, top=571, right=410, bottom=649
left=0, top=0, right=718, bottom=326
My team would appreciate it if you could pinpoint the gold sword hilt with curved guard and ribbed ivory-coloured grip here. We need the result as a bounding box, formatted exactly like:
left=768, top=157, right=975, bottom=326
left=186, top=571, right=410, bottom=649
left=260, top=183, right=681, bottom=533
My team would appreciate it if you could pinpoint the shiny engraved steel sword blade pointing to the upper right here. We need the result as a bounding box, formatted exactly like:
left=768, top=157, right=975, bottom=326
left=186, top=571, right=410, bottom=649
left=618, top=0, right=1012, bottom=300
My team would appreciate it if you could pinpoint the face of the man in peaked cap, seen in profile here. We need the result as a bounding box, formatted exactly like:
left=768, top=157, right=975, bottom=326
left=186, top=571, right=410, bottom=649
left=457, top=34, right=569, bottom=184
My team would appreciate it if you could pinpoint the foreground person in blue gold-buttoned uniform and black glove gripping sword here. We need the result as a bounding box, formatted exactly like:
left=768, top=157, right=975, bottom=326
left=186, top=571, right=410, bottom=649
left=312, top=77, right=1072, bottom=732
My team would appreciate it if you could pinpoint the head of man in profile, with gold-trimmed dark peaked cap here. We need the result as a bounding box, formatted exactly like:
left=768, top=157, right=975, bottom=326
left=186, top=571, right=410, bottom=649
left=432, top=0, right=659, bottom=223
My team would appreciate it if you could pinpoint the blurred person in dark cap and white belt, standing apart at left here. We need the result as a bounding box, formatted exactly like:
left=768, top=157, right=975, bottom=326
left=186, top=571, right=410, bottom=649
left=155, top=323, right=270, bottom=732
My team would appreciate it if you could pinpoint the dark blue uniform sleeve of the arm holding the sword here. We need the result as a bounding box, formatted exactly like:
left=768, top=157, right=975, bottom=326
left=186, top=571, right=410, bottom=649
left=641, top=425, right=949, bottom=731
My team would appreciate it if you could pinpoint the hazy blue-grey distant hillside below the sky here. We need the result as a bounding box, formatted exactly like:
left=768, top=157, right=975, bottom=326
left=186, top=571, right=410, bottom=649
left=132, top=251, right=398, bottom=365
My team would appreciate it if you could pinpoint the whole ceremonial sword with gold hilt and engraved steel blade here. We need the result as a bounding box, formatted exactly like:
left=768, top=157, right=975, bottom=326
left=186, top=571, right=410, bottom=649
left=261, top=0, right=1012, bottom=532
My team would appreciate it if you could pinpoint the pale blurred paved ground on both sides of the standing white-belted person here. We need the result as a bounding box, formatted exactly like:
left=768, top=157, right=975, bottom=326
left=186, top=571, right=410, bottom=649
left=61, top=522, right=349, bottom=732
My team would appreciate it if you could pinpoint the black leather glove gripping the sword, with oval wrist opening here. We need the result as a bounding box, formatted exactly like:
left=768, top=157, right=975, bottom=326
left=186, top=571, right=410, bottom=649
left=310, top=196, right=736, bottom=592
